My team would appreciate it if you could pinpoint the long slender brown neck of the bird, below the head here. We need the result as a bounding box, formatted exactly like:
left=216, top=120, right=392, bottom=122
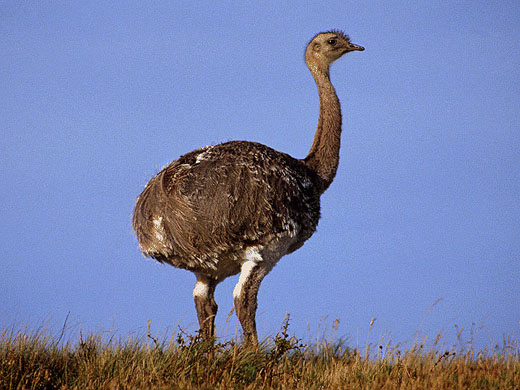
left=304, top=66, right=341, bottom=192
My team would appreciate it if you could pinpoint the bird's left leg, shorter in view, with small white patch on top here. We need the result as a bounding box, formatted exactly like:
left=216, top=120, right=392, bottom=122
left=193, top=274, right=218, bottom=339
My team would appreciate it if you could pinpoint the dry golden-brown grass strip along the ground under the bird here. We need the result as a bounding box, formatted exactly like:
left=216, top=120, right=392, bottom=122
left=0, top=318, right=520, bottom=390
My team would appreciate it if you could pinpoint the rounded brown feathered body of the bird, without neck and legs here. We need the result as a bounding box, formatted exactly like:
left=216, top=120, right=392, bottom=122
left=134, top=141, right=321, bottom=279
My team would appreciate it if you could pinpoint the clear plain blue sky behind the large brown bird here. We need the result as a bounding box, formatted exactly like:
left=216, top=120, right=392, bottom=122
left=0, top=0, right=520, bottom=346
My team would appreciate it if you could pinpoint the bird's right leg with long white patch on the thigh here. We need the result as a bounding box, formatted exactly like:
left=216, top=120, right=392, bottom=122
left=233, top=260, right=269, bottom=345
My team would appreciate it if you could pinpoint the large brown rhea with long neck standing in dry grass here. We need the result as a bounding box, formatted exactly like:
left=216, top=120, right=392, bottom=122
left=132, top=30, right=364, bottom=344
